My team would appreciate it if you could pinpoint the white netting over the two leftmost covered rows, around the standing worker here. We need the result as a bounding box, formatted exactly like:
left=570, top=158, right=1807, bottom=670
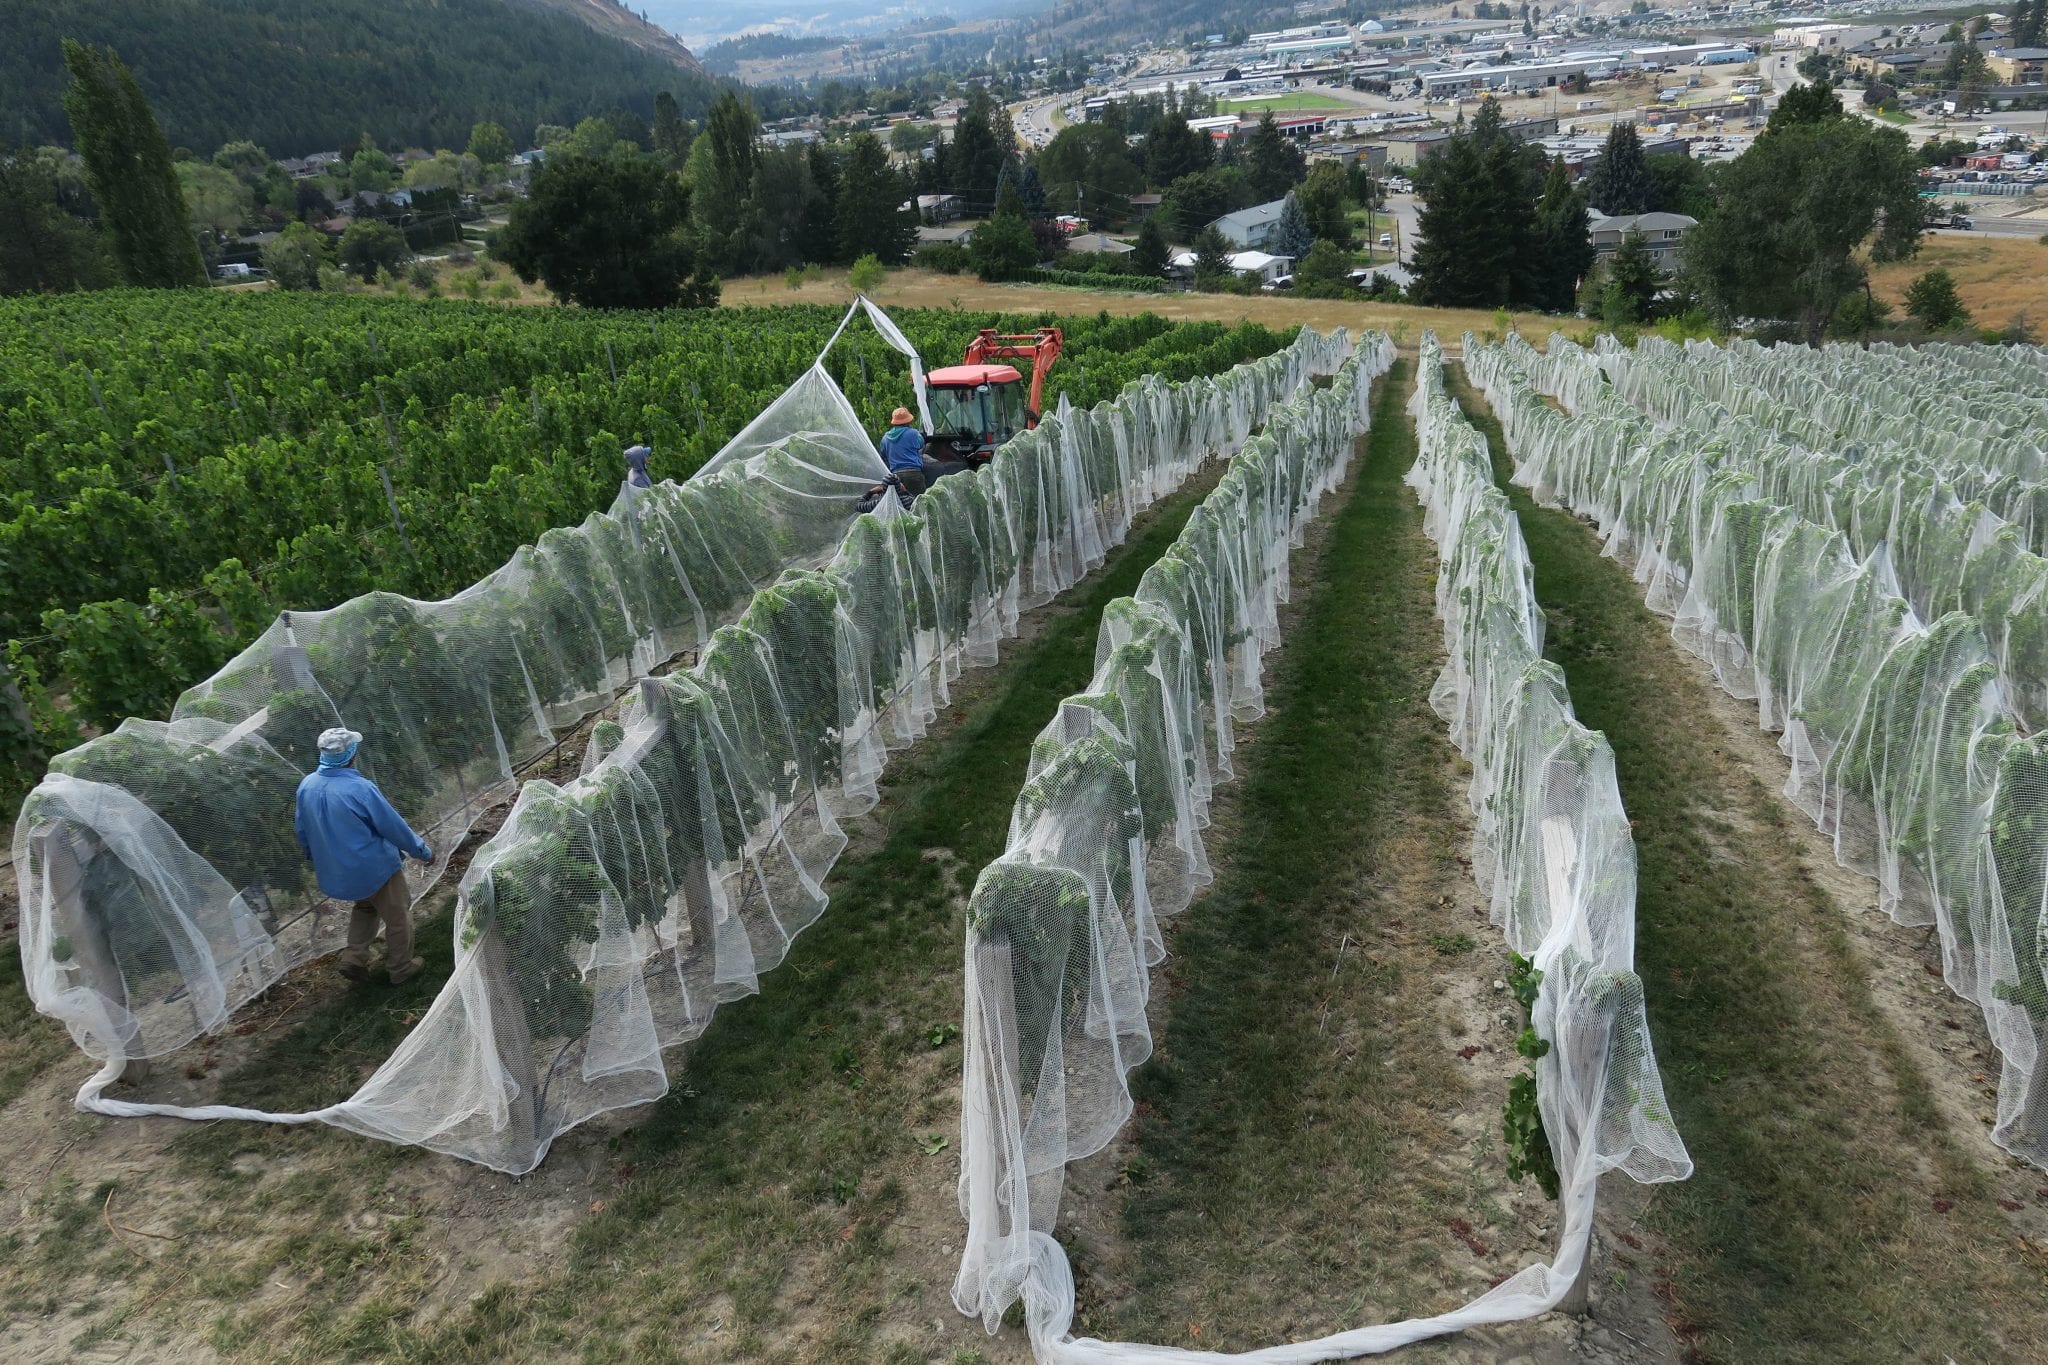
left=16, top=300, right=1348, bottom=1173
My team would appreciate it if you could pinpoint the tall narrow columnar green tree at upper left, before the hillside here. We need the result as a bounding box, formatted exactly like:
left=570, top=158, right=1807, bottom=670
left=63, top=39, right=207, bottom=289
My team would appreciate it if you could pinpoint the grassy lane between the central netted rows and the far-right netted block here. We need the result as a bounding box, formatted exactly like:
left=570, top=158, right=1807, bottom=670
left=1452, top=370, right=2042, bottom=1363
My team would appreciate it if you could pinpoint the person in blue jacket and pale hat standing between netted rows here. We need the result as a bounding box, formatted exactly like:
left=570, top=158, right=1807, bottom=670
left=295, top=726, right=434, bottom=986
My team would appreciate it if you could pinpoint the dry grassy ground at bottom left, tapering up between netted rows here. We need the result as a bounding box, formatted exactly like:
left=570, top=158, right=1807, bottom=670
left=0, top=467, right=1221, bottom=1361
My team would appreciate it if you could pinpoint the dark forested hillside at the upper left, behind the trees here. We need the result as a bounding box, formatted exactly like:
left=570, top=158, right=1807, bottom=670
left=0, top=0, right=715, bottom=156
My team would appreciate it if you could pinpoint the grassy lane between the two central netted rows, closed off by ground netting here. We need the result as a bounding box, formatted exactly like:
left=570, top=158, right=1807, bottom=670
left=1105, top=362, right=1511, bottom=1349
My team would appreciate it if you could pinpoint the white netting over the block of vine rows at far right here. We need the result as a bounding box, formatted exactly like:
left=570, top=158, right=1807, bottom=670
left=1466, top=327, right=2048, bottom=1166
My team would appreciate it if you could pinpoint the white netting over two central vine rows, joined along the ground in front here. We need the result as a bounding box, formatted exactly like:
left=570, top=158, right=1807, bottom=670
left=954, top=336, right=1692, bottom=1363
